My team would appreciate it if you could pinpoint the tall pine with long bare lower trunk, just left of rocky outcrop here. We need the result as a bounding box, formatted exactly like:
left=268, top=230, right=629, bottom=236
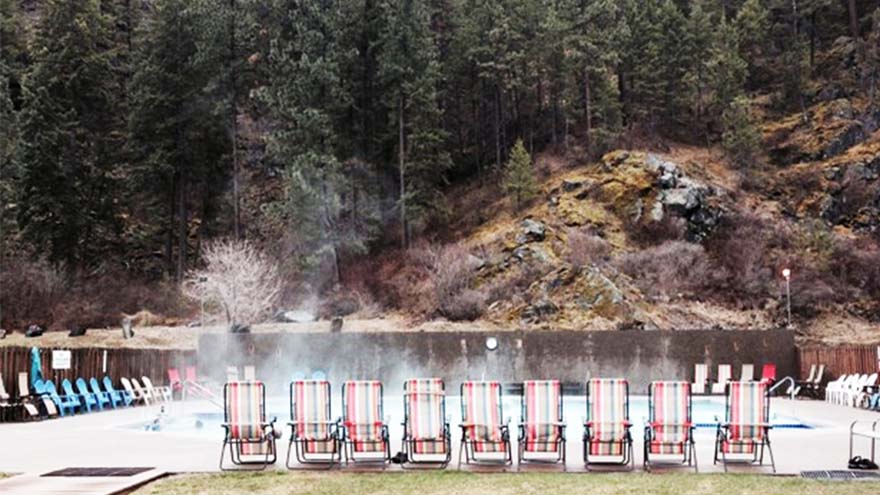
left=378, top=0, right=450, bottom=247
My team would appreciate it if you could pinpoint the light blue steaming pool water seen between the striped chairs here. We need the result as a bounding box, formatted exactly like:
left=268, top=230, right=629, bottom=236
left=124, top=395, right=813, bottom=438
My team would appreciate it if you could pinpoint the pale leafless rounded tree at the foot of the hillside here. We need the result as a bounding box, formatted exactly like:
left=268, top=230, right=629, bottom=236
left=183, top=240, right=281, bottom=326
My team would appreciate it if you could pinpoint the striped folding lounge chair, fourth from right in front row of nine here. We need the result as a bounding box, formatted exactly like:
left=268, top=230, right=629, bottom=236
left=517, top=380, right=565, bottom=469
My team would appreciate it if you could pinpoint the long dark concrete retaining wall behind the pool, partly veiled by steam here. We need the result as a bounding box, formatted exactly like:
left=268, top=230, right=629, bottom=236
left=198, top=330, right=797, bottom=393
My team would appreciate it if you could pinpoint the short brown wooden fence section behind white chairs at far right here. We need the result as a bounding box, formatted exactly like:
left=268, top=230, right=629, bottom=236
left=798, top=345, right=880, bottom=380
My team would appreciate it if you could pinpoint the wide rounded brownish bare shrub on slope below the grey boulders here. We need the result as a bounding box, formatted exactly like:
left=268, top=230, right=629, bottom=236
left=616, top=241, right=712, bottom=299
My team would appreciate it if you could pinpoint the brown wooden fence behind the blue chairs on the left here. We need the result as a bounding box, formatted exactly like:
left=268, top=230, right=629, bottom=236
left=0, top=347, right=196, bottom=397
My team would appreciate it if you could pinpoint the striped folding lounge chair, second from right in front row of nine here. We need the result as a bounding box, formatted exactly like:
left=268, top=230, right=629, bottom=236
left=644, top=382, right=697, bottom=471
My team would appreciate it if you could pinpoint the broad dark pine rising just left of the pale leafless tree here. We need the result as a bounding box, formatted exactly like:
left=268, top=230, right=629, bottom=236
left=129, top=0, right=229, bottom=280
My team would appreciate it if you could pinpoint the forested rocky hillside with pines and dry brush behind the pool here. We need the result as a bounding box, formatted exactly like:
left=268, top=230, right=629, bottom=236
left=0, top=0, right=880, bottom=342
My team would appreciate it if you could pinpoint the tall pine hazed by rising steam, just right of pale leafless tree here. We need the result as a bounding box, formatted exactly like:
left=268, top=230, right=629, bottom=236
left=262, top=0, right=371, bottom=283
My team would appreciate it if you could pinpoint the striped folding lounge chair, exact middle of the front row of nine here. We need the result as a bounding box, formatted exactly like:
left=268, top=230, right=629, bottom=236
left=458, top=381, right=513, bottom=468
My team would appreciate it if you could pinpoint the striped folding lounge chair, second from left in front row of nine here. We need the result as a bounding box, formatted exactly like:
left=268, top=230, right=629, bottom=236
left=286, top=380, right=342, bottom=469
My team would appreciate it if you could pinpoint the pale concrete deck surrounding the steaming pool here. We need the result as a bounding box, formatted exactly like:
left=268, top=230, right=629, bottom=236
left=0, top=398, right=880, bottom=491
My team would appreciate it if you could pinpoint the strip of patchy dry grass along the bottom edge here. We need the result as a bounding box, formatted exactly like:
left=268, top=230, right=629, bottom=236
left=135, top=471, right=880, bottom=495
